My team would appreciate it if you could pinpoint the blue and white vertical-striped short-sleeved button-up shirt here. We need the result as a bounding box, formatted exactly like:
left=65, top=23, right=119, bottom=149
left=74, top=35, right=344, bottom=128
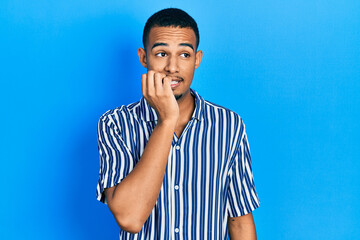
left=97, top=90, right=259, bottom=240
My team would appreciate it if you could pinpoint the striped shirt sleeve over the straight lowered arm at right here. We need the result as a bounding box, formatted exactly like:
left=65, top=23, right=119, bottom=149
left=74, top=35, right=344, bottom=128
left=227, top=125, right=260, bottom=217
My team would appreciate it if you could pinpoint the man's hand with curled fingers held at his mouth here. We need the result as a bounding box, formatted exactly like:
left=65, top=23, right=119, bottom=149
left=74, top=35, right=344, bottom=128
left=141, top=70, right=179, bottom=123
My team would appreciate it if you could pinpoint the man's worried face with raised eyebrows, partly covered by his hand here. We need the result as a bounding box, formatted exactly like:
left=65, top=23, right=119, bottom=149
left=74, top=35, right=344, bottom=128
left=139, top=27, right=202, bottom=100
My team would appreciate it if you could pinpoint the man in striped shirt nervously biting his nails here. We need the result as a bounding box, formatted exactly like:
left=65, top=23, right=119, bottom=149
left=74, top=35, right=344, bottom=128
left=97, top=8, right=259, bottom=239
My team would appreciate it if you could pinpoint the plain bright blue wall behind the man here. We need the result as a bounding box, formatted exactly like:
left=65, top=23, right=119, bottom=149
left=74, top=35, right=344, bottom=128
left=0, top=0, right=360, bottom=240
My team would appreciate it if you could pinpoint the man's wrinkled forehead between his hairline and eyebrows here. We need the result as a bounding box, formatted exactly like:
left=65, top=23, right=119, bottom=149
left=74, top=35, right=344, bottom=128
left=149, top=27, right=196, bottom=47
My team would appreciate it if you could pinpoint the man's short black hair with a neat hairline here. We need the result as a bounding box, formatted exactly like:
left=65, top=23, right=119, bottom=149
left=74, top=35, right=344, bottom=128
left=143, top=8, right=200, bottom=51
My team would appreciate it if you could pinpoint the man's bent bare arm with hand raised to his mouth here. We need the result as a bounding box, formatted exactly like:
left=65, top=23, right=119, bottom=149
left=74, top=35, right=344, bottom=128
left=105, top=71, right=179, bottom=233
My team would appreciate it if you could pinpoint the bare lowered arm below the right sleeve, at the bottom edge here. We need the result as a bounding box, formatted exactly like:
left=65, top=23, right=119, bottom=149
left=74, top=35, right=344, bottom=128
left=228, top=213, right=256, bottom=240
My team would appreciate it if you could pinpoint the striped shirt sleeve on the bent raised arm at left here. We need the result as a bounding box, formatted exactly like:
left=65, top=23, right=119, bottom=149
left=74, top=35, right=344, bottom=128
left=96, top=113, right=135, bottom=203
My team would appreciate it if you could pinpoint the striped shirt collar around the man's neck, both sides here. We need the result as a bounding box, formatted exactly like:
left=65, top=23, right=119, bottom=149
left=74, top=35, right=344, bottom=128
left=140, top=88, right=205, bottom=122
